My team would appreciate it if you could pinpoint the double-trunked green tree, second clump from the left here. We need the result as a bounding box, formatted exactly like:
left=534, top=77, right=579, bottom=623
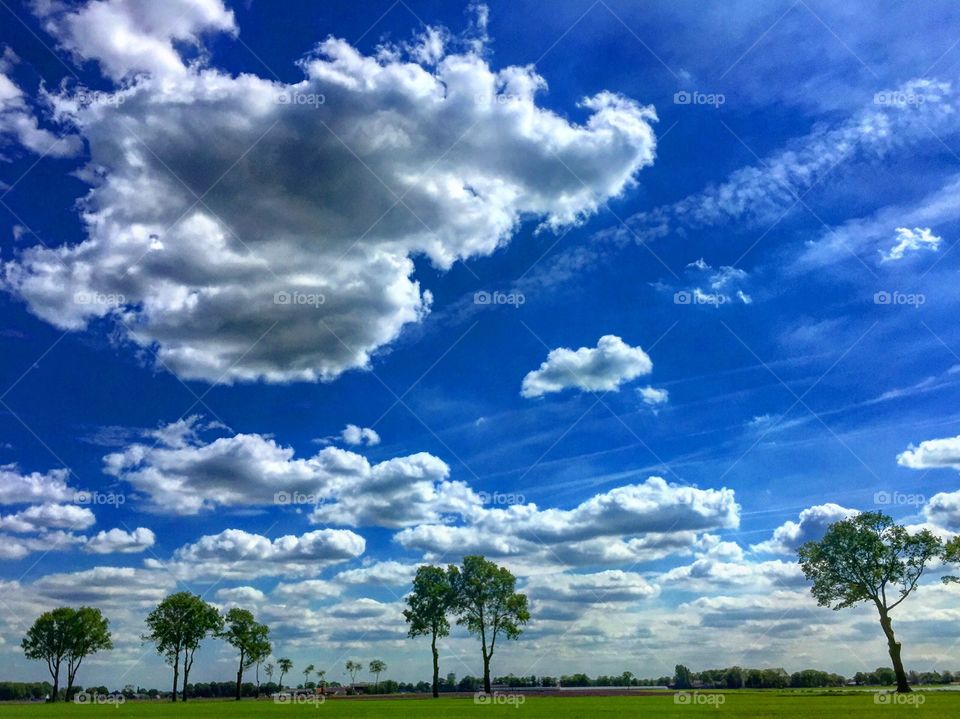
left=143, top=592, right=223, bottom=701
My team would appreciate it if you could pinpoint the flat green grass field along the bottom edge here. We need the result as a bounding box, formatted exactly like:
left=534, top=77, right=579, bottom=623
left=0, top=691, right=960, bottom=719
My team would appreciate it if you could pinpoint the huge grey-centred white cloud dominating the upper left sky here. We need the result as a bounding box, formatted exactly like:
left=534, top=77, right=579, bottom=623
left=0, top=14, right=656, bottom=382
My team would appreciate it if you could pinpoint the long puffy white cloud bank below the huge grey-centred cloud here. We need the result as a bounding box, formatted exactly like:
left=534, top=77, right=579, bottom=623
left=104, top=417, right=482, bottom=527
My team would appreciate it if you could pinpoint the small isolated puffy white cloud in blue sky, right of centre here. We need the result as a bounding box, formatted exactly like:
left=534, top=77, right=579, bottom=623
left=520, top=335, right=653, bottom=398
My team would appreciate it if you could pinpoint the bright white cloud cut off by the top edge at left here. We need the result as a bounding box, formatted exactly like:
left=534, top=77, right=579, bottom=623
left=34, top=0, right=237, bottom=80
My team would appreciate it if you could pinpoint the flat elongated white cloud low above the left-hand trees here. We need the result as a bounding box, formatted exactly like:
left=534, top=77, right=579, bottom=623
left=152, top=529, right=366, bottom=579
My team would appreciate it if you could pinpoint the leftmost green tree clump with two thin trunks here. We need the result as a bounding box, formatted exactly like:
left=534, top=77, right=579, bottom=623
left=20, top=607, right=113, bottom=702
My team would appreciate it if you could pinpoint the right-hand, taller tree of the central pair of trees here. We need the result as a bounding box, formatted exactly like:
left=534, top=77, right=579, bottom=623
left=448, top=554, right=530, bottom=694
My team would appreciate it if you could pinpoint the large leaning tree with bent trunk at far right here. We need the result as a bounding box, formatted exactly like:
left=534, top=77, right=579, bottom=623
left=799, top=512, right=943, bottom=692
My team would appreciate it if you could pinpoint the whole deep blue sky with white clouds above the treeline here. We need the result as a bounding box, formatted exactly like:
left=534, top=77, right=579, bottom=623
left=0, top=0, right=960, bottom=686
